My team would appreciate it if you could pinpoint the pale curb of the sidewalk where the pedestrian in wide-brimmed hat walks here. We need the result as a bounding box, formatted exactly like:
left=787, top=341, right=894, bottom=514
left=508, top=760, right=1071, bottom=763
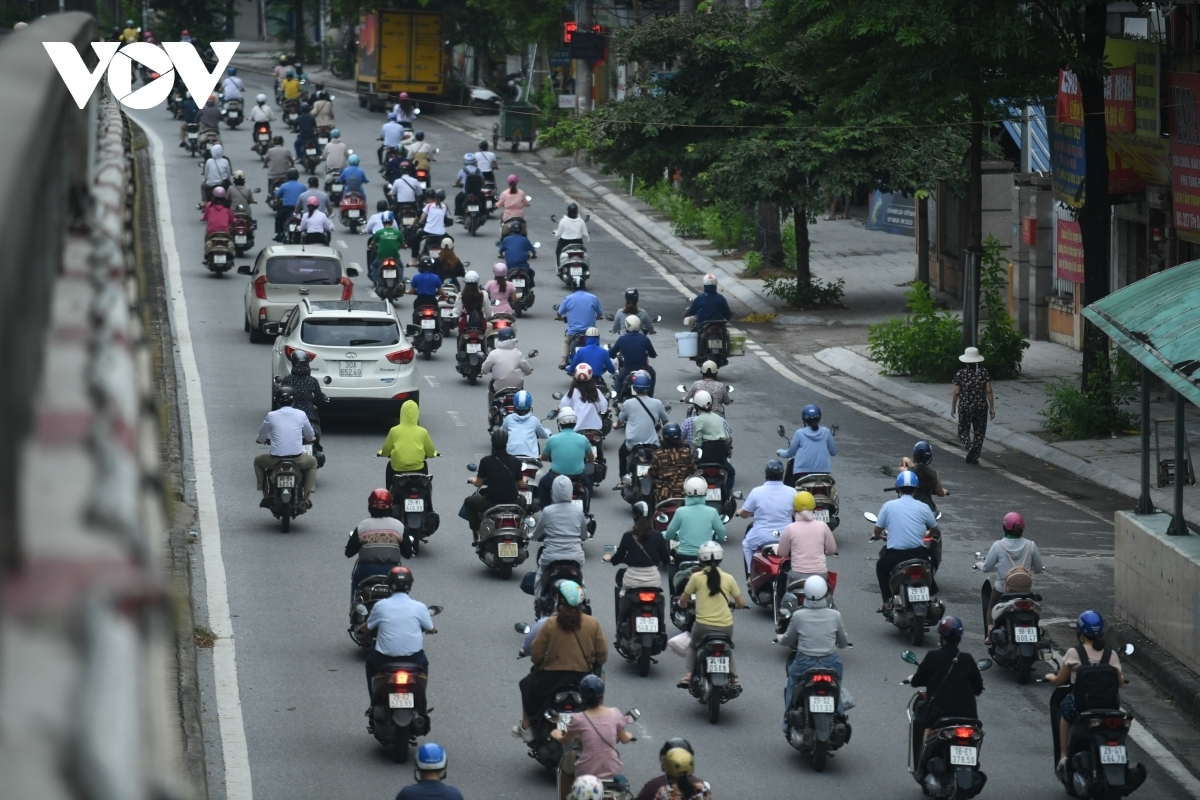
left=816, top=348, right=1200, bottom=519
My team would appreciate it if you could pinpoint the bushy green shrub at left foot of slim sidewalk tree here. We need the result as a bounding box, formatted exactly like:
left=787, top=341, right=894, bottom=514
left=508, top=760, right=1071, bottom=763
left=866, top=282, right=962, bottom=383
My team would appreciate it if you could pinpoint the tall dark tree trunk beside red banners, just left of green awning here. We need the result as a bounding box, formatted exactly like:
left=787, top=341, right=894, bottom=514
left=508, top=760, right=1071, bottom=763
left=1079, top=1, right=1111, bottom=391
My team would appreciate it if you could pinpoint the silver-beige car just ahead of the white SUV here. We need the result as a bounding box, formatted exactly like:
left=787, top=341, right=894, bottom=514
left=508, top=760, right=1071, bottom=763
left=238, top=245, right=359, bottom=342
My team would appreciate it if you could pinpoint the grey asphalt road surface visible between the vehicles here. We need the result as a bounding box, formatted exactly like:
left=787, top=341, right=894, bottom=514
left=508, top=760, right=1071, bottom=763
left=129, top=77, right=1189, bottom=800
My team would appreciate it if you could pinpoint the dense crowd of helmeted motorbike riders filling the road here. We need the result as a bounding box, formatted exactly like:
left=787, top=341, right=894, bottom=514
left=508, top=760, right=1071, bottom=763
left=178, top=65, right=1145, bottom=800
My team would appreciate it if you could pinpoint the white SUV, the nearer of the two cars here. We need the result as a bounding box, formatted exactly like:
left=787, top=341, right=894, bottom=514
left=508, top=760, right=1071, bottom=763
left=263, top=299, right=421, bottom=412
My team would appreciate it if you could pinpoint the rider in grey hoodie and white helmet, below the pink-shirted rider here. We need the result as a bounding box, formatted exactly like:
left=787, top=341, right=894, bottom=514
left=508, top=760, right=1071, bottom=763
left=775, top=575, right=848, bottom=734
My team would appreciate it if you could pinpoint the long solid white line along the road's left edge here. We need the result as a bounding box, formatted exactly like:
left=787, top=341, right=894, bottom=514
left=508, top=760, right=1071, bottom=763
left=142, top=126, right=253, bottom=800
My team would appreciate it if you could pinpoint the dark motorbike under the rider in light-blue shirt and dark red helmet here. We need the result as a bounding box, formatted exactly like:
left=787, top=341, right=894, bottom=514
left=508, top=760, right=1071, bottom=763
left=367, top=606, right=443, bottom=764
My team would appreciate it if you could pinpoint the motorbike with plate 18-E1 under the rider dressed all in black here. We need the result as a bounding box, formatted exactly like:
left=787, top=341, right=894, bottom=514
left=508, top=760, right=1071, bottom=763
left=900, top=650, right=993, bottom=800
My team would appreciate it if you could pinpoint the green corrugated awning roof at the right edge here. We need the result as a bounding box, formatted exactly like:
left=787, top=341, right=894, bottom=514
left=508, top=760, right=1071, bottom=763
left=1084, top=261, right=1200, bottom=405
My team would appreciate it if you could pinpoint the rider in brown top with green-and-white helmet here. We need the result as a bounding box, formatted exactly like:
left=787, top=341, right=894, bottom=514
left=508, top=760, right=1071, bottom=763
left=512, top=582, right=608, bottom=744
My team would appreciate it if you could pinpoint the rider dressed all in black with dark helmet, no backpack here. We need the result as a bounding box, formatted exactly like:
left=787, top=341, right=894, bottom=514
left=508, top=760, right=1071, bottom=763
left=908, top=615, right=983, bottom=781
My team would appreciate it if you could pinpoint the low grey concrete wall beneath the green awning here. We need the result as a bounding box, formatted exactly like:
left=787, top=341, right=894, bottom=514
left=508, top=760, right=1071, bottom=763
left=1114, top=511, right=1200, bottom=673
